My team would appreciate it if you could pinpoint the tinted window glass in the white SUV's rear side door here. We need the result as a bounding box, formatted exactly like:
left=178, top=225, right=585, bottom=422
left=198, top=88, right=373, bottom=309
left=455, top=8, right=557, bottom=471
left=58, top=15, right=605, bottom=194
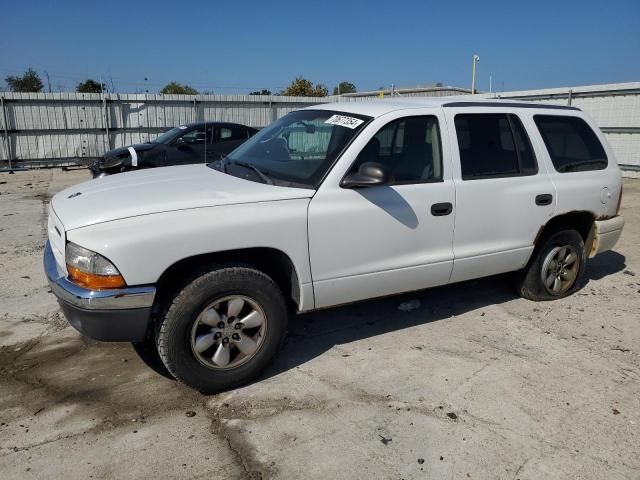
left=455, top=113, right=538, bottom=180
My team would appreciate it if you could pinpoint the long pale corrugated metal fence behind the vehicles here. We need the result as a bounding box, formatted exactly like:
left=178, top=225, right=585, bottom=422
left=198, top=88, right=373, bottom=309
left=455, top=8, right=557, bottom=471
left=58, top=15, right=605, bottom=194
left=0, top=82, right=640, bottom=169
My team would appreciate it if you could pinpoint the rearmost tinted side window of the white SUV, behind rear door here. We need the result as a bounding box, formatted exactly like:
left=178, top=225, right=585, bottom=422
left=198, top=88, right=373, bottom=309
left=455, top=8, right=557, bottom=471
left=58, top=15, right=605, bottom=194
left=533, top=115, right=608, bottom=172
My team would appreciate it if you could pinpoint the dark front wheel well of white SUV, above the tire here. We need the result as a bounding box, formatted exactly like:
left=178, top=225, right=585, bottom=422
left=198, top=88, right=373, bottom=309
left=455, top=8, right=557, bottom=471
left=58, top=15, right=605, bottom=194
left=156, top=247, right=301, bottom=308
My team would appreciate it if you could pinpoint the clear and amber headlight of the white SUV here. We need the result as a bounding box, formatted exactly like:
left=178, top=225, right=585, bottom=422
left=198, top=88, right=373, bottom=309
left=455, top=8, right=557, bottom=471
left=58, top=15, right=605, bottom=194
left=65, top=242, right=126, bottom=290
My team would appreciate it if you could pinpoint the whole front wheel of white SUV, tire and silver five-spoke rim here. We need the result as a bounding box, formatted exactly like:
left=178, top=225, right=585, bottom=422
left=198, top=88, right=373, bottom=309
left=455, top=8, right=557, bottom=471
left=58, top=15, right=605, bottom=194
left=157, top=266, right=287, bottom=393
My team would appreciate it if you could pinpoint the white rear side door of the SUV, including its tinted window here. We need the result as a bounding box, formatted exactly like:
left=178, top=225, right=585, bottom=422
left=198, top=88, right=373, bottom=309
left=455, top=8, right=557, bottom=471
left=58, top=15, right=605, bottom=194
left=444, top=107, right=556, bottom=282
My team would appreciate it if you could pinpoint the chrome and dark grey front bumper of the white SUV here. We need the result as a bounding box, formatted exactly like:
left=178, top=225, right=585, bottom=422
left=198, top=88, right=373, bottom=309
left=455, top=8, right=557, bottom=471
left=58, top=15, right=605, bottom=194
left=44, top=241, right=156, bottom=342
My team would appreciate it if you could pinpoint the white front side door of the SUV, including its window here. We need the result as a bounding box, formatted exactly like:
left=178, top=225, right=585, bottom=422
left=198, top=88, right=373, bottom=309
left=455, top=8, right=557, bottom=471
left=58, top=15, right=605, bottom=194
left=308, top=113, right=455, bottom=308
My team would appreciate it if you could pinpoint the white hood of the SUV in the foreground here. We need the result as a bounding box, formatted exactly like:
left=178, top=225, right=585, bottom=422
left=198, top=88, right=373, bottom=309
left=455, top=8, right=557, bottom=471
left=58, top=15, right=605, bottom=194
left=51, top=165, right=314, bottom=230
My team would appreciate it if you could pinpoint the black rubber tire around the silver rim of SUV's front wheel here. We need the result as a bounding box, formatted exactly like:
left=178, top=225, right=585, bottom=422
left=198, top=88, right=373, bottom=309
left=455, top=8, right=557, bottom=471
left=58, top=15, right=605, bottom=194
left=157, top=266, right=287, bottom=394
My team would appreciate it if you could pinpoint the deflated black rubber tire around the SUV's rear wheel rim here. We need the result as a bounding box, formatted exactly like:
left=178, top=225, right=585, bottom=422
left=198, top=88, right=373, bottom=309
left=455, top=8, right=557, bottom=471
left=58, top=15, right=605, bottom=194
left=516, top=230, right=586, bottom=301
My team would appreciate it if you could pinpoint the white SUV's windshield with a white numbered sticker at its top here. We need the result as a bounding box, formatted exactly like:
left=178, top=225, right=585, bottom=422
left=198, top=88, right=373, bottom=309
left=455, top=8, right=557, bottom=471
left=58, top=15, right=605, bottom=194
left=210, top=110, right=371, bottom=188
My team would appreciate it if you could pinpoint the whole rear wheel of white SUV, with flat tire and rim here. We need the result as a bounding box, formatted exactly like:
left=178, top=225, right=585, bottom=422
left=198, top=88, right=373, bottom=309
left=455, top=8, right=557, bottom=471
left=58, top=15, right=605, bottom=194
left=517, top=230, right=586, bottom=301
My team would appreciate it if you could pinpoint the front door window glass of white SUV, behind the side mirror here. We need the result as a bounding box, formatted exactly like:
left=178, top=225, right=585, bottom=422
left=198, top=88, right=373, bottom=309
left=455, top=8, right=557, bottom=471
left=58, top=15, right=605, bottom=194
left=351, top=115, right=442, bottom=185
